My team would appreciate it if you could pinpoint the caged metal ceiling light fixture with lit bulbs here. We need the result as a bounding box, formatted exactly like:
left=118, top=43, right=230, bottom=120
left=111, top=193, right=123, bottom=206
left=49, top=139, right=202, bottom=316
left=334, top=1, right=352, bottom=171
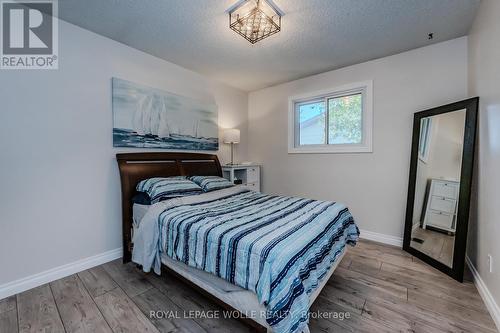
left=228, top=0, right=283, bottom=44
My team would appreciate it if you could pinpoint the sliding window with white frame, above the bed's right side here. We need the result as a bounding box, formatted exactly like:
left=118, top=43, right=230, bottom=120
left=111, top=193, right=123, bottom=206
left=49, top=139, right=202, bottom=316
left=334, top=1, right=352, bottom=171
left=288, top=82, right=372, bottom=153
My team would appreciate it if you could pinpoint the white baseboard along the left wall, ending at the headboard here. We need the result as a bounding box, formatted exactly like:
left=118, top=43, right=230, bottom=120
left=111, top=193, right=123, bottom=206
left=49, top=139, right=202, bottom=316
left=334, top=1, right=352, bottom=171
left=0, top=248, right=122, bottom=299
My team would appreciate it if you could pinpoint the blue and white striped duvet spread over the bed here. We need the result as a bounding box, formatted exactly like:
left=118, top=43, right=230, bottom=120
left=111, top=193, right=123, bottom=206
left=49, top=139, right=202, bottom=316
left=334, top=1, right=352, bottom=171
left=133, top=188, right=359, bottom=333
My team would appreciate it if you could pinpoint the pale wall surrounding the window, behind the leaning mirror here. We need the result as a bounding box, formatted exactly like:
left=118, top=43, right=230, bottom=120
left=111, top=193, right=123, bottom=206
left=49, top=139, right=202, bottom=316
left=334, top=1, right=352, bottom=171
left=248, top=37, right=467, bottom=237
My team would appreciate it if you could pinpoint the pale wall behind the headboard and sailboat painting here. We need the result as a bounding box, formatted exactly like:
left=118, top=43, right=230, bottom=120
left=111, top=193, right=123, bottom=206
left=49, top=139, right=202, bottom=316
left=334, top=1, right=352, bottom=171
left=0, top=22, right=248, bottom=286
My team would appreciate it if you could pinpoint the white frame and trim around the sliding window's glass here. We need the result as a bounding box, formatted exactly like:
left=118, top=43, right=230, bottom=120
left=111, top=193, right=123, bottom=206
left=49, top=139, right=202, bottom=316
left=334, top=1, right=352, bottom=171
left=288, top=81, right=373, bottom=154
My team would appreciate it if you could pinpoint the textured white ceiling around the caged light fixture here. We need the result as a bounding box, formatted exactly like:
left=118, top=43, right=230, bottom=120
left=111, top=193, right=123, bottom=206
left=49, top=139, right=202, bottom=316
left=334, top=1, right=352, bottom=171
left=59, top=0, right=480, bottom=91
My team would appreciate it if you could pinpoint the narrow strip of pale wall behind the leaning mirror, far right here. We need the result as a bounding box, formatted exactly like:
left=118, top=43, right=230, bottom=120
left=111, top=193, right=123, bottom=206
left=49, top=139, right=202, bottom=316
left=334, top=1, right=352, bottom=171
left=468, top=0, right=500, bottom=320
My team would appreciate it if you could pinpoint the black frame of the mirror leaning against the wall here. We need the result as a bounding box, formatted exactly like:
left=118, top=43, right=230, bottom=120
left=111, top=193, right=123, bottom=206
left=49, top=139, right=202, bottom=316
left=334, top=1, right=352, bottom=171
left=403, top=97, right=479, bottom=282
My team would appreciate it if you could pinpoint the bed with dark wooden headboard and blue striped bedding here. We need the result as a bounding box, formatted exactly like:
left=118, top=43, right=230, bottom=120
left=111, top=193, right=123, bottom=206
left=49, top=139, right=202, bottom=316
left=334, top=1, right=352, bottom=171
left=117, top=153, right=359, bottom=333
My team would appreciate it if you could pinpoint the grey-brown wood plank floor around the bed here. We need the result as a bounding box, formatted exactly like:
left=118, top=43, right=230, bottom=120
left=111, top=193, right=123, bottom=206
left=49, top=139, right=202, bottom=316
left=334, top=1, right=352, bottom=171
left=0, top=241, right=497, bottom=333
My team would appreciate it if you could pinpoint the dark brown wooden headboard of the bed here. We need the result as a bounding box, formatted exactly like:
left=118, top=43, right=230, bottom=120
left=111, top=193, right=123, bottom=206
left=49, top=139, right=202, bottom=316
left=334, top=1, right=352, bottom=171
left=116, top=153, right=222, bottom=263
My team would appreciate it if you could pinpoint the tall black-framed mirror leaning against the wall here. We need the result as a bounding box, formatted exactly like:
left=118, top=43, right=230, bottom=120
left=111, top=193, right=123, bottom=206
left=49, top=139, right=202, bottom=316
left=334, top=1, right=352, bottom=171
left=403, top=98, right=479, bottom=282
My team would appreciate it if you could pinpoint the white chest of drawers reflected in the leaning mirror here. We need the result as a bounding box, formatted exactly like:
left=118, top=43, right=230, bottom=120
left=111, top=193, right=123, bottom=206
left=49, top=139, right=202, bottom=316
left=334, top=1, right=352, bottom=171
left=423, top=179, right=460, bottom=233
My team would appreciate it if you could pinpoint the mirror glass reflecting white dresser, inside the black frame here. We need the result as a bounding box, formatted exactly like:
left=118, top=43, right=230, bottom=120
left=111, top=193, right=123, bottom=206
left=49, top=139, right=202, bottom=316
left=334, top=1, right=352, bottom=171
left=410, top=110, right=466, bottom=267
